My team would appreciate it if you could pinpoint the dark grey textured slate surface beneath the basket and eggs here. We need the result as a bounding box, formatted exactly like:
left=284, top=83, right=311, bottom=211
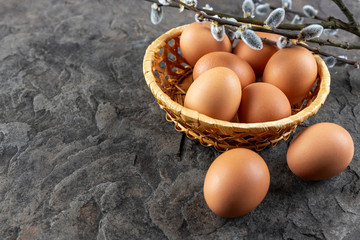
left=0, top=0, right=360, bottom=240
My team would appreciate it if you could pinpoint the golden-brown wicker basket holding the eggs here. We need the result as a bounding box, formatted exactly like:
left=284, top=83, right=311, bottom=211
left=143, top=25, right=330, bottom=151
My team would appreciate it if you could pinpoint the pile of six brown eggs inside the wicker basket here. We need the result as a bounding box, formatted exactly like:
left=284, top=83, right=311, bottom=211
left=180, top=22, right=318, bottom=123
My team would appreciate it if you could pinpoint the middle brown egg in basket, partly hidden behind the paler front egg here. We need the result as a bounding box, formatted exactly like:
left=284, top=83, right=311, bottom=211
left=193, top=52, right=256, bottom=88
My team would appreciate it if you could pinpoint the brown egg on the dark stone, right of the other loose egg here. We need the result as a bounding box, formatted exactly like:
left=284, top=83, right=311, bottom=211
left=287, top=122, right=354, bottom=180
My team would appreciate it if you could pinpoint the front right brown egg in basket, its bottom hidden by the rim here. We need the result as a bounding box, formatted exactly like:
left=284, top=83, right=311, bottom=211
left=238, top=82, right=291, bottom=123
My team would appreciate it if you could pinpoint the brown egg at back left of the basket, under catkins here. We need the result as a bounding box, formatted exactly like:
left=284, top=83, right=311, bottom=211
left=180, top=22, right=232, bottom=67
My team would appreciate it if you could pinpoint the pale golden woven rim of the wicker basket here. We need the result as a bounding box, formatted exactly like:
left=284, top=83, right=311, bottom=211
left=143, top=25, right=330, bottom=132
